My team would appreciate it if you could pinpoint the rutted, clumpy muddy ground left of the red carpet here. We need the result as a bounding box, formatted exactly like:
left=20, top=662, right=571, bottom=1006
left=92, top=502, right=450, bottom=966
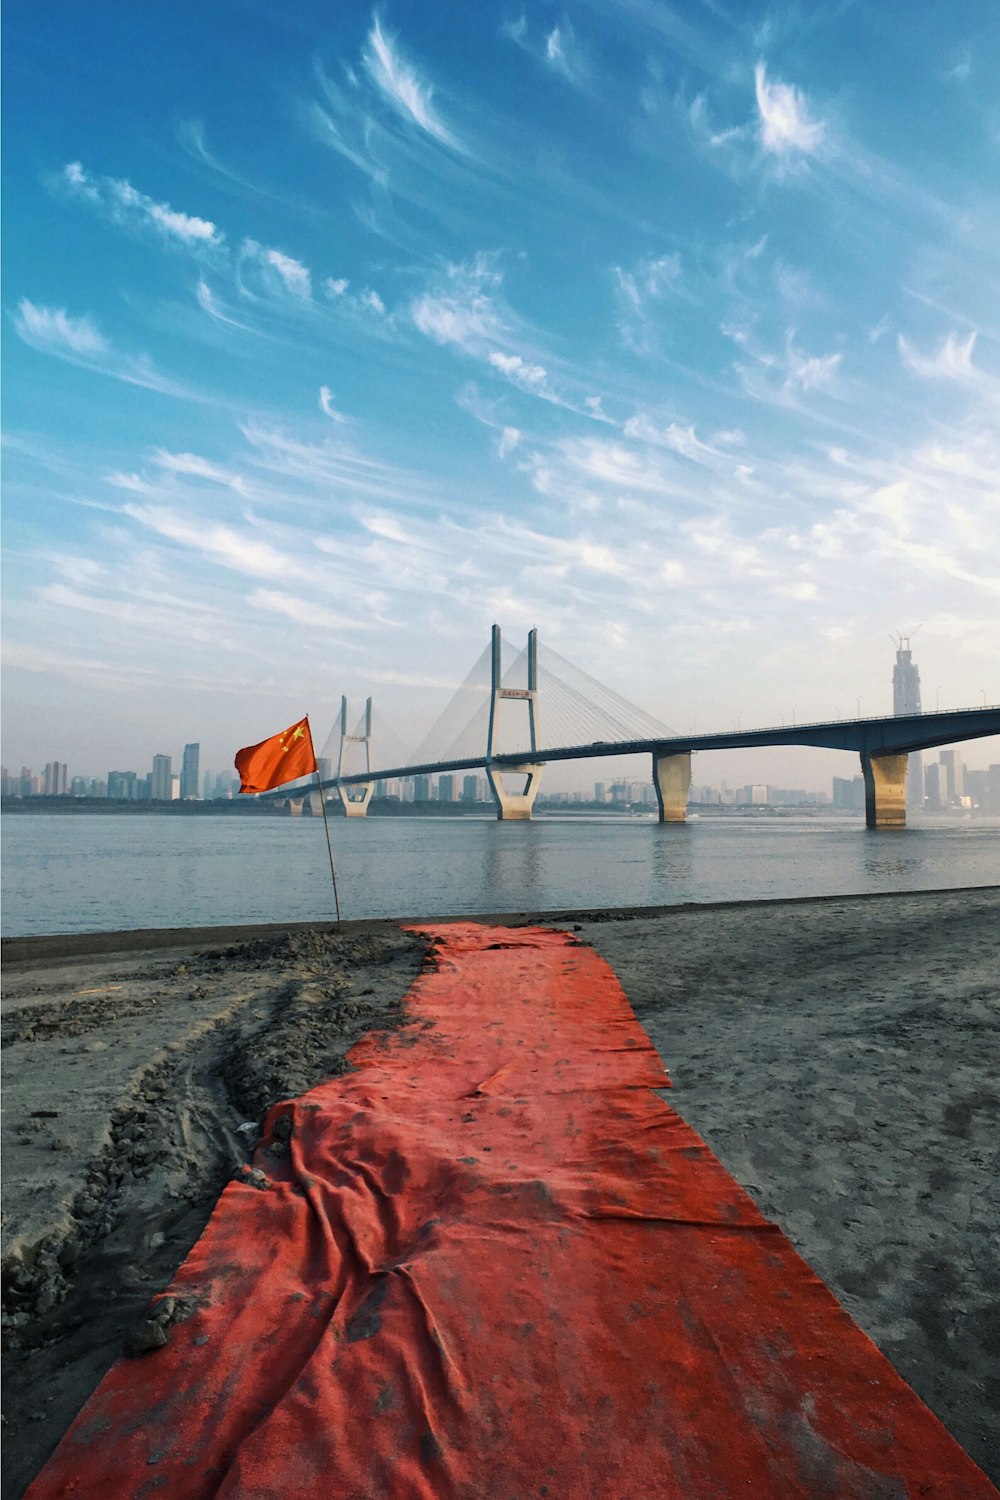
left=1, top=924, right=424, bottom=1500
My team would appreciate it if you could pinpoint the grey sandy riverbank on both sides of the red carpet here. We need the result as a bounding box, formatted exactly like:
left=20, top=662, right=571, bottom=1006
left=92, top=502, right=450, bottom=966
left=3, top=888, right=1000, bottom=1494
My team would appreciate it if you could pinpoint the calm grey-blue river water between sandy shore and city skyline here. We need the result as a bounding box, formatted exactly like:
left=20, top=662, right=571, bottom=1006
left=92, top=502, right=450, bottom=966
left=1, top=813, right=1000, bottom=936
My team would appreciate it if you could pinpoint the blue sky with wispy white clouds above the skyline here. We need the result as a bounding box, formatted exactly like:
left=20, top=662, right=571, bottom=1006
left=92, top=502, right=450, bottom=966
left=3, top=0, right=1000, bottom=788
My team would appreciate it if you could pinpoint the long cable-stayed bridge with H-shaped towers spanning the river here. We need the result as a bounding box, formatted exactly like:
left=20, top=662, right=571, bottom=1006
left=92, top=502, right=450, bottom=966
left=289, top=626, right=1000, bottom=828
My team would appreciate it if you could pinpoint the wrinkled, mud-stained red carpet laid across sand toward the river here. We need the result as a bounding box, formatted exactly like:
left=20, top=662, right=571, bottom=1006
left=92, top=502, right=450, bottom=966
left=27, top=923, right=997, bottom=1500
